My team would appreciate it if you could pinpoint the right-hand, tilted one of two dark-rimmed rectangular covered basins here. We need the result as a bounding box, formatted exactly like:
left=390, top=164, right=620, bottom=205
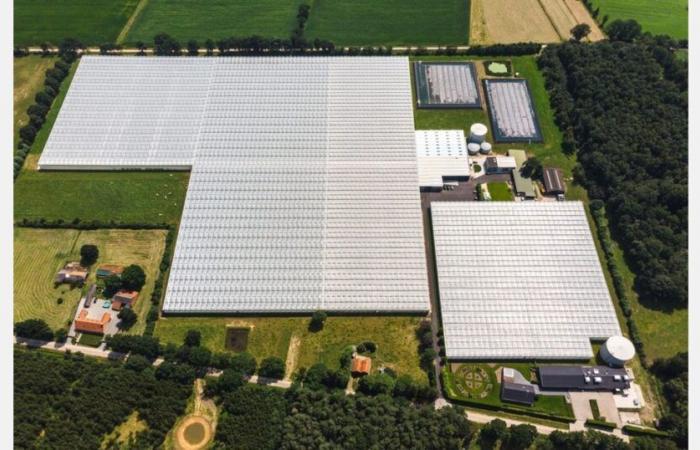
left=484, top=80, right=542, bottom=142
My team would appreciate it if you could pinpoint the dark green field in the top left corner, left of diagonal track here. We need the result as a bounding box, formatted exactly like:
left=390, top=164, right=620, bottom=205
left=14, top=0, right=138, bottom=45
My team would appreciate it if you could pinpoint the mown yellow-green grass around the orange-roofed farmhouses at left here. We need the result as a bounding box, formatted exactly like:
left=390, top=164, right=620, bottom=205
left=14, top=228, right=166, bottom=333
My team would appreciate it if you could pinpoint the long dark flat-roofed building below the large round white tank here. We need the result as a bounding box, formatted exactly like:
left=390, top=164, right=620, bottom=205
left=537, top=366, right=630, bottom=392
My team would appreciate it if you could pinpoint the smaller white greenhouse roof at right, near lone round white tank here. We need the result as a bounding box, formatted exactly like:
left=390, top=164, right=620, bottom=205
left=431, top=202, right=620, bottom=359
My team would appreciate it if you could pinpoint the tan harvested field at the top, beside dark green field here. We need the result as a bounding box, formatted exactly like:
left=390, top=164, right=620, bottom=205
left=469, top=0, right=605, bottom=45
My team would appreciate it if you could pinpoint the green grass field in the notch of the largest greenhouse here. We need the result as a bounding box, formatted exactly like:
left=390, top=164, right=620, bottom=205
left=14, top=170, right=189, bottom=223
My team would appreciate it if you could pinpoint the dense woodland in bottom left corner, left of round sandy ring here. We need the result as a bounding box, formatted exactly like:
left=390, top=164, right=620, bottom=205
left=14, top=349, right=192, bottom=450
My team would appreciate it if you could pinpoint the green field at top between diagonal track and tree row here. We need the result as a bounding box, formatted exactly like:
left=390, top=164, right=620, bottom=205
left=125, top=0, right=302, bottom=45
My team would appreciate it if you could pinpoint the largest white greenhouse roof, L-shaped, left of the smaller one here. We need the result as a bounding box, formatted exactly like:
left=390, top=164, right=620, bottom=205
left=40, top=57, right=430, bottom=313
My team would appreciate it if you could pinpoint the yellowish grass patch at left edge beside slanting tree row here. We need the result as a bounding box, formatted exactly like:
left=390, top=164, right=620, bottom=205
left=12, top=55, right=56, bottom=153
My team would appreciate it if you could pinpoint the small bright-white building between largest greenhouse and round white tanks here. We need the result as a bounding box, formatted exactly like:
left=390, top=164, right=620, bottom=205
left=415, top=130, right=470, bottom=190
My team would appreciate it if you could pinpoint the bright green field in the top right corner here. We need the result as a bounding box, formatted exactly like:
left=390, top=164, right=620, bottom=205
left=592, top=0, right=688, bottom=38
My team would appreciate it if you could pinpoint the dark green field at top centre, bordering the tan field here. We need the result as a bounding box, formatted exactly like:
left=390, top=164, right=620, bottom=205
left=306, top=0, right=469, bottom=45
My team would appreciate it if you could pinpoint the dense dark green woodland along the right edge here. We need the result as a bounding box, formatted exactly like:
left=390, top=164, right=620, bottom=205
left=539, top=35, right=688, bottom=310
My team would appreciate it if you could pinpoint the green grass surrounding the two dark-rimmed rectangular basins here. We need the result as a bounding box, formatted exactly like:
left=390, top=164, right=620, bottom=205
left=411, top=56, right=576, bottom=177
